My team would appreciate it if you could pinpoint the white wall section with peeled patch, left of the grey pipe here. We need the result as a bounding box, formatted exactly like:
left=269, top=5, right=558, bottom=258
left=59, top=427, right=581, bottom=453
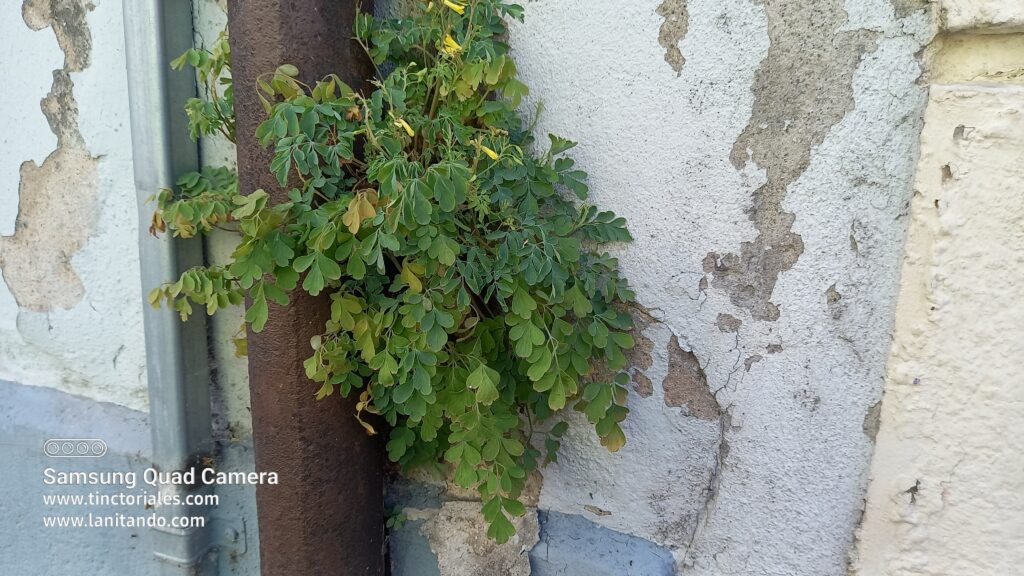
left=0, top=0, right=146, bottom=409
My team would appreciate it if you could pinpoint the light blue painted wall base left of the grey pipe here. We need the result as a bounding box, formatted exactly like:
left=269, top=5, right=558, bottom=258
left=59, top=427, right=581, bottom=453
left=0, top=381, right=158, bottom=576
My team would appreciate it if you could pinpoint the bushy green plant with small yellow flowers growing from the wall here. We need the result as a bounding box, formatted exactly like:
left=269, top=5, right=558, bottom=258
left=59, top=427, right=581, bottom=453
left=150, top=0, right=634, bottom=542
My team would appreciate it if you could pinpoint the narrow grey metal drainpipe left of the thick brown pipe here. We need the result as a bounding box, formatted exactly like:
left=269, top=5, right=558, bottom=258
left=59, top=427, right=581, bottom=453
left=124, top=0, right=219, bottom=576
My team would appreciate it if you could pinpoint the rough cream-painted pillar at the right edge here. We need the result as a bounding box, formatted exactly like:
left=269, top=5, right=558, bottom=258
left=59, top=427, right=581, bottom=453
left=852, top=7, right=1024, bottom=576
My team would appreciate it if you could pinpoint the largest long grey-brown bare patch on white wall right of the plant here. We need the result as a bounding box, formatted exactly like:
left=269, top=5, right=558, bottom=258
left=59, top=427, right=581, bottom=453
left=703, top=0, right=878, bottom=321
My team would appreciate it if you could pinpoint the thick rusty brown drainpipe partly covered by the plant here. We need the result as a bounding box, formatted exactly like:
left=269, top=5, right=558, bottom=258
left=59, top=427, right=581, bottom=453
left=227, top=0, right=384, bottom=576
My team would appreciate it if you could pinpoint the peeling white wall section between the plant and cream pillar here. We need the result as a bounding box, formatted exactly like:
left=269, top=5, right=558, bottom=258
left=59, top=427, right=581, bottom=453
left=370, top=0, right=932, bottom=576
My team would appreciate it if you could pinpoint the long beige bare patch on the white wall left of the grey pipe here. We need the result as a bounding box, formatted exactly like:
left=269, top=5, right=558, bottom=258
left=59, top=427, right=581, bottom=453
left=0, top=0, right=99, bottom=312
